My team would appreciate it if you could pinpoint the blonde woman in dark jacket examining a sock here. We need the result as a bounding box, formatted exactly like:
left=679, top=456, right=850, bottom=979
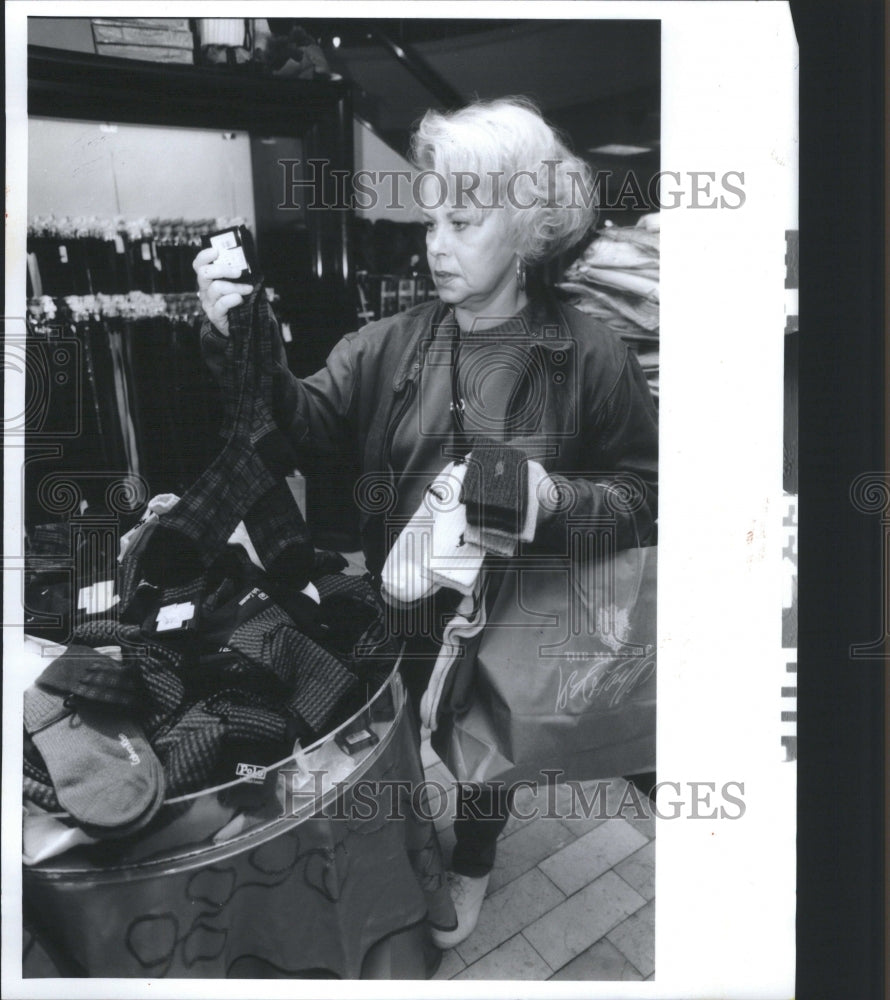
left=195, top=99, right=657, bottom=948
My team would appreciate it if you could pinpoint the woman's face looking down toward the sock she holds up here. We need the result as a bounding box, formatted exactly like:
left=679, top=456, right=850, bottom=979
left=423, top=178, right=517, bottom=315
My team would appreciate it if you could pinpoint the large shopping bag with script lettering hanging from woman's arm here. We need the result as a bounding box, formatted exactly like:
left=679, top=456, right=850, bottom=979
left=433, top=546, right=657, bottom=783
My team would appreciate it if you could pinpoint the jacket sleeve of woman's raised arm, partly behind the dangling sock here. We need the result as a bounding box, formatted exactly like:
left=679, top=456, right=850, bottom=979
left=201, top=319, right=359, bottom=452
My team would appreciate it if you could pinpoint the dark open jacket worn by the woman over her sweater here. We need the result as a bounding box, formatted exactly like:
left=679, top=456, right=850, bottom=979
left=202, top=297, right=658, bottom=573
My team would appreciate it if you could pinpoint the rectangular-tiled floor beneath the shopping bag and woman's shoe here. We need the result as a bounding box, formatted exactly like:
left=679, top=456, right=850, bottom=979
left=422, top=740, right=655, bottom=980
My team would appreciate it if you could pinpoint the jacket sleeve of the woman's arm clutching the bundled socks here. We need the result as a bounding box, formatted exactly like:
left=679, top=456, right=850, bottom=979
left=535, top=347, right=658, bottom=553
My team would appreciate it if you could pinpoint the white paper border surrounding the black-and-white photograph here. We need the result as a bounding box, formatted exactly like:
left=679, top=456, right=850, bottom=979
left=2, top=0, right=797, bottom=998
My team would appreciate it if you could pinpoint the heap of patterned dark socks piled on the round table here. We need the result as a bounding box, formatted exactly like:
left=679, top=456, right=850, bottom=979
left=24, top=546, right=397, bottom=838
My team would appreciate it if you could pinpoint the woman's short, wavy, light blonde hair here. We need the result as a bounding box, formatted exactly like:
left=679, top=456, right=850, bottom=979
left=411, top=97, right=596, bottom=264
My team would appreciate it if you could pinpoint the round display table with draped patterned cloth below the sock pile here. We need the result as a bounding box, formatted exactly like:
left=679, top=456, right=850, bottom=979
left=23, top=665, right=454, bottom=979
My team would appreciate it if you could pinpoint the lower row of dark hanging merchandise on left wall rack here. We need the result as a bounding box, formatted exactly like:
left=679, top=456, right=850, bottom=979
left=25, top=292, right=220, bottom=524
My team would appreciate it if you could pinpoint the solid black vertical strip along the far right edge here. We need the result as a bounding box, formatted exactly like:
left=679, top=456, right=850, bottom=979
left=792, top=0, right=890, bottom=1000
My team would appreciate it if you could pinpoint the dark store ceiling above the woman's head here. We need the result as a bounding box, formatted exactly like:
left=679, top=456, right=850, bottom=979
left=299, top=18, right=661, bottom=169
